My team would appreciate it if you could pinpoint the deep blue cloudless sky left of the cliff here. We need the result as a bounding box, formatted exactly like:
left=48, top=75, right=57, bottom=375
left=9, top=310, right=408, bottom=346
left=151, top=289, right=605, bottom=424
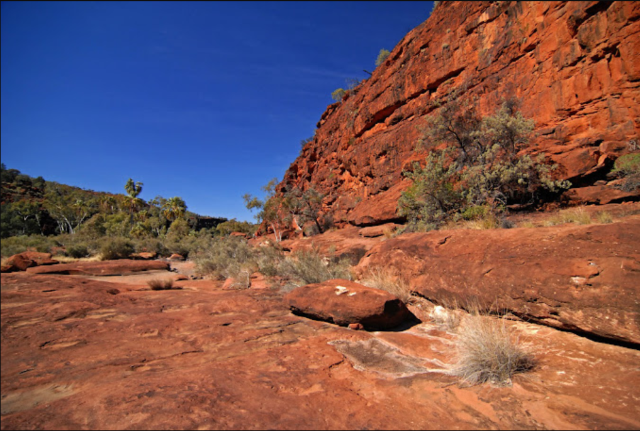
left=0, top=1, right=433, bottom=221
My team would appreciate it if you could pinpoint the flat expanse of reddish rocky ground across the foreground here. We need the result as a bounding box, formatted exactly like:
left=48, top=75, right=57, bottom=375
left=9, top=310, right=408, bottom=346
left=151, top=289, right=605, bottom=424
left=1, top=204, right=640, bottom=429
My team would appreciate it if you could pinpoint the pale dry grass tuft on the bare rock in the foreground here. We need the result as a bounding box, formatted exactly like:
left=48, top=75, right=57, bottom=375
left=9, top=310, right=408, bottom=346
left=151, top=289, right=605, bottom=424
left=450, top=313, right=534, bottom=386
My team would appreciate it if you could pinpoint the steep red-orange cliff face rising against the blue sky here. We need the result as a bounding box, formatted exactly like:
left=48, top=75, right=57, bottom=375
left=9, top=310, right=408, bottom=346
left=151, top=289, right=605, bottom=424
left=280, top=1, right=640, bottom=226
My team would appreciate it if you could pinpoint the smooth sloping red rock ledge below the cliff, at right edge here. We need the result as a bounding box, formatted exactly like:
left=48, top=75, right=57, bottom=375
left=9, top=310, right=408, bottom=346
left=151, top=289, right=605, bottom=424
left=356, top=216, right=640, bottom=348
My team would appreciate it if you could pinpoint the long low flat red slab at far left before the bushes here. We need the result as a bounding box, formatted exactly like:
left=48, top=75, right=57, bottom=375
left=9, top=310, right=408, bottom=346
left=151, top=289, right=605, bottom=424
left=27, top=259, right=171, bottom=275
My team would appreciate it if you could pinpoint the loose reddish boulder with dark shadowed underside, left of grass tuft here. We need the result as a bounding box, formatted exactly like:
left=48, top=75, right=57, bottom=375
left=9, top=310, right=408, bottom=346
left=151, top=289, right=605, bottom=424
left=284, top=279, right=413, bottom=330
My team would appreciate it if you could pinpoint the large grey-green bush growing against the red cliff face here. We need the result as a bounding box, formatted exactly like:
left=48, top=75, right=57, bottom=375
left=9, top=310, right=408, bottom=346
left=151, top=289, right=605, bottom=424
left=398, top=95, right=571, bottom=230
